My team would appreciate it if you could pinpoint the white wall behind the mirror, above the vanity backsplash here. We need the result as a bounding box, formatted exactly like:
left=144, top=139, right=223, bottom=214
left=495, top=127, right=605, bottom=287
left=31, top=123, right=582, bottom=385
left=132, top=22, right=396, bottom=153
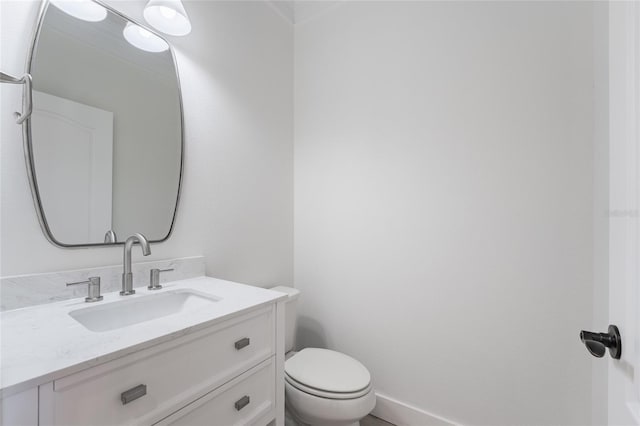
left=0, top=0, right=293, bottom=286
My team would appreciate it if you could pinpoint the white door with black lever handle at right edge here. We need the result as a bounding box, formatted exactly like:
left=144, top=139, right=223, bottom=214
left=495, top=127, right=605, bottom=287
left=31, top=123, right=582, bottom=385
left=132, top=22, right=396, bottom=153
left=603, top=1, right=640, bottom=425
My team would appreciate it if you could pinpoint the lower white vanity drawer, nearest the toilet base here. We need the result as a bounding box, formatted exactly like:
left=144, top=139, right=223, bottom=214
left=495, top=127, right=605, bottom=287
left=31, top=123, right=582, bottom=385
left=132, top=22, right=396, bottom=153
left=156, top=358, right=275, bottom=426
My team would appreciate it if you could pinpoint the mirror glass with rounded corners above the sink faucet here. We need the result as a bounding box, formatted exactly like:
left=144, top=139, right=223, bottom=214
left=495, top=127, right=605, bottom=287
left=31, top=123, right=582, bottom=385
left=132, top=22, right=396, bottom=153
left=25, top=0, right=183, bottom=247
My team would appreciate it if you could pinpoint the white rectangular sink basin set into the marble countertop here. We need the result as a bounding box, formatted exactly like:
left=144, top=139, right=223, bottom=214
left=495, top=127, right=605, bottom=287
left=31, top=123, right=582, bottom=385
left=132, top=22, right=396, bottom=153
left=69, top=290, right=220, bottom=331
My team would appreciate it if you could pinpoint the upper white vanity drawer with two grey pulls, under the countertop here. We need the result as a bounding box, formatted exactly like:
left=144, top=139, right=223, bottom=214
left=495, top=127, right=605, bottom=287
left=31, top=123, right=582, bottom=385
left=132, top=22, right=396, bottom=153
left=41, top=307, right=275, bottom=426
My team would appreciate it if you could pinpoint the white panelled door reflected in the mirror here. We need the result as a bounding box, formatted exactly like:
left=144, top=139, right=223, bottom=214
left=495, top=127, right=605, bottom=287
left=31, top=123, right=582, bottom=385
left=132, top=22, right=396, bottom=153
left=31, top=90, right=113, bottom=244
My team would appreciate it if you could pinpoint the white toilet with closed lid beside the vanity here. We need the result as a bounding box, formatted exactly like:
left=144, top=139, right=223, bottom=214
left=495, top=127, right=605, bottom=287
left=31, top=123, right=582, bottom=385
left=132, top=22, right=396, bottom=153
left=271, top=286, right=376, bottom=426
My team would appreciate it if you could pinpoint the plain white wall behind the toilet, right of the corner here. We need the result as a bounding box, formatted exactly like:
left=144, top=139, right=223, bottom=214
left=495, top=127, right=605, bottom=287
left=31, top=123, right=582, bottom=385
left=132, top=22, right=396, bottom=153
left=294, top=2, right=594, bottom=425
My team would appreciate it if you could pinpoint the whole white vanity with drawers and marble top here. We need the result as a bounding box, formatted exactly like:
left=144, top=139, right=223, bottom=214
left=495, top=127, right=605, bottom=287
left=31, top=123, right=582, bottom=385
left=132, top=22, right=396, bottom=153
left=0, top=276, right=286, bottom=426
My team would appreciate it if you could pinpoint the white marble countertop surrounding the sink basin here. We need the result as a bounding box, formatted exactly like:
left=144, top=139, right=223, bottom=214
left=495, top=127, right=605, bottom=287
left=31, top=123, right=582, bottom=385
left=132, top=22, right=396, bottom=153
left=0, top=277, right=286, bottom=396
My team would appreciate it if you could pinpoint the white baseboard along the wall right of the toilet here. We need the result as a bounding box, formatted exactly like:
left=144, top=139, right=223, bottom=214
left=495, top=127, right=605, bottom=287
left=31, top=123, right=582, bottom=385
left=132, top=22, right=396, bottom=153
left=371, top=393, right=456, bottom=426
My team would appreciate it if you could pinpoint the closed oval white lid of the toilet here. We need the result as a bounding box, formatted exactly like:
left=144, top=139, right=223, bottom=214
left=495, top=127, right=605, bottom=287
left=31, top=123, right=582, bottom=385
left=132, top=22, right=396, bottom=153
left=284, top=348, right=371, bottom=393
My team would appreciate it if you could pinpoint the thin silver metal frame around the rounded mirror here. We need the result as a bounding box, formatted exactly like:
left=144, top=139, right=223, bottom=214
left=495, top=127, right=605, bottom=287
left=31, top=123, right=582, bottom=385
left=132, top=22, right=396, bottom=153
left=22, top=0, right=184, bottom=249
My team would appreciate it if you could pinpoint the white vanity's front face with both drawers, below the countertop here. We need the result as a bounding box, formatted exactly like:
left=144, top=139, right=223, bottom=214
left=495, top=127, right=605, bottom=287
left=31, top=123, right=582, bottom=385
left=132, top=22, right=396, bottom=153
left=39, top=304, right=281, bottom=426
